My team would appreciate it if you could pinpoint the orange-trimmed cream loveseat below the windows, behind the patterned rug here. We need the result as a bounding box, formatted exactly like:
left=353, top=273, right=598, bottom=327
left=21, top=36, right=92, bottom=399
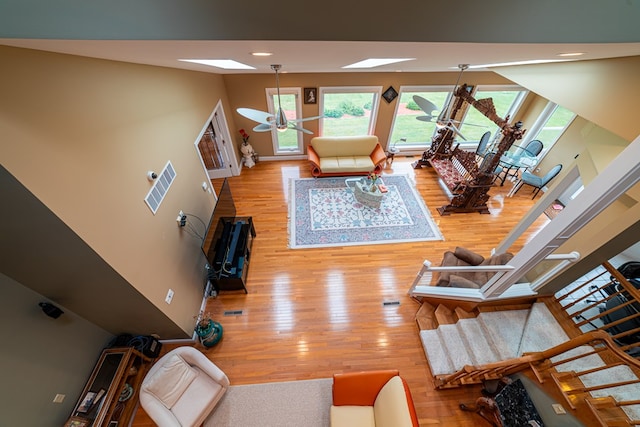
left=307, top=135, right=387, bottom=178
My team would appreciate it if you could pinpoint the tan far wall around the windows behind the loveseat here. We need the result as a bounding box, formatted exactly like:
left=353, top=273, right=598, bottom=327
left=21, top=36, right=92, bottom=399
left=224, top=71, right=512, bottom=156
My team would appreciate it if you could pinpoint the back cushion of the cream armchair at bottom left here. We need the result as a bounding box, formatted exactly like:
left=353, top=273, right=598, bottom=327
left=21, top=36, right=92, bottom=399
left=143, top=354, right=197, bottom=409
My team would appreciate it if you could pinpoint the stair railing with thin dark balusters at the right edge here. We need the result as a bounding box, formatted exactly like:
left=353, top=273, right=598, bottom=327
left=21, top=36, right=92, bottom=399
left=556, top=262, right=640, bottom=357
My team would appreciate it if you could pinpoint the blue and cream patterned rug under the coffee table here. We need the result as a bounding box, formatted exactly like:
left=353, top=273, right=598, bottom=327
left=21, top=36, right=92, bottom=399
left=289, top=175, right=444, bottom=249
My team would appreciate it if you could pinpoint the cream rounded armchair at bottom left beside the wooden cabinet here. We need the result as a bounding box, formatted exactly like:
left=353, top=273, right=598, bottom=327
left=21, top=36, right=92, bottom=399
left=140, top=347, right=229, bottom=427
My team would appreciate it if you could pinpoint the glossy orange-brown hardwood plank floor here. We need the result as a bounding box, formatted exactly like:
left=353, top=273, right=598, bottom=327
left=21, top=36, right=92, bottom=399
left=133, top=156, right=549, bottom=427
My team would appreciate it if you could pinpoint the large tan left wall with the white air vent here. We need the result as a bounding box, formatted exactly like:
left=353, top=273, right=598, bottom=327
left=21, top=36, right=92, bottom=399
left=0, top=47, right=230, bottom=334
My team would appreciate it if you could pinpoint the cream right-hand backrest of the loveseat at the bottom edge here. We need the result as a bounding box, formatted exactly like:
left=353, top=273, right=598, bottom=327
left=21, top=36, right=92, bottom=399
left=373, top=376, right=413, bottom=427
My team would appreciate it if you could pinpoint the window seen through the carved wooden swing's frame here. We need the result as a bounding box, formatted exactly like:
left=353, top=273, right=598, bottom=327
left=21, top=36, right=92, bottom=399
left=460, top=86, right=527, bottom=145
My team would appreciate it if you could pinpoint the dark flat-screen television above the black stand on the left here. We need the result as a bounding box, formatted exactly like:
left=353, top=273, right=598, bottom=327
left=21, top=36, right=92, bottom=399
left=202, top=178, right=236, bottom=267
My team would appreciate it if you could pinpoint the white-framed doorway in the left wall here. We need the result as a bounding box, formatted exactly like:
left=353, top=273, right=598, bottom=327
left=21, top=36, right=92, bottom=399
left=198, top=113, right=232, bottom=179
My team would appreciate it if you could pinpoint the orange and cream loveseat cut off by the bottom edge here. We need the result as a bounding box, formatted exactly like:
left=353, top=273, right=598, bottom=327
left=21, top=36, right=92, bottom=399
left=331, top=370, right=418, bottom=427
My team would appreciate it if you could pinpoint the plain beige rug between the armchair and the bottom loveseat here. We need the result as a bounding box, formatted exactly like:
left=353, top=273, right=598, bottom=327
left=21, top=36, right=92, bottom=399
left=204, top=378, right=333, bottom=427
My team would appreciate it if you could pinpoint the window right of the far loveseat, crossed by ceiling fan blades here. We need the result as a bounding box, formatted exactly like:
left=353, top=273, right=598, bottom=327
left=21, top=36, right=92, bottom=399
left=389, top=86, right=453, bottom=148
